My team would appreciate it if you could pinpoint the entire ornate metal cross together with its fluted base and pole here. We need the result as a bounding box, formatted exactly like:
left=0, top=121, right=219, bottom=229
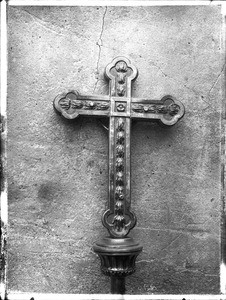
left=54, top=57, right=184, bottom=294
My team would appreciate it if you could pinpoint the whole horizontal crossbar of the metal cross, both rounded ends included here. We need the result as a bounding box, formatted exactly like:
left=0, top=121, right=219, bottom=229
left=54, top=91, right=185, bottom=126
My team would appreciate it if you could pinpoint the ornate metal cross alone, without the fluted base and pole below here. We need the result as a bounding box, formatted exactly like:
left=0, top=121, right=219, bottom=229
left=54, top=57, right=184, bottom=238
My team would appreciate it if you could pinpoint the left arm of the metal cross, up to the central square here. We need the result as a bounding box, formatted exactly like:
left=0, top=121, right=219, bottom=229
left=53, top=91, right=110, bottom=119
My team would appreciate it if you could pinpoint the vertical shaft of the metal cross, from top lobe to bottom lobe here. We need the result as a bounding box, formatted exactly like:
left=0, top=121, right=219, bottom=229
left=103, top=57, right=137, bottom=237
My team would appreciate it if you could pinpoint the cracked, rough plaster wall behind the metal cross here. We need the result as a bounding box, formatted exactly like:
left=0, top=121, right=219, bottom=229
left=7, top=6, right=223, bottom=294
